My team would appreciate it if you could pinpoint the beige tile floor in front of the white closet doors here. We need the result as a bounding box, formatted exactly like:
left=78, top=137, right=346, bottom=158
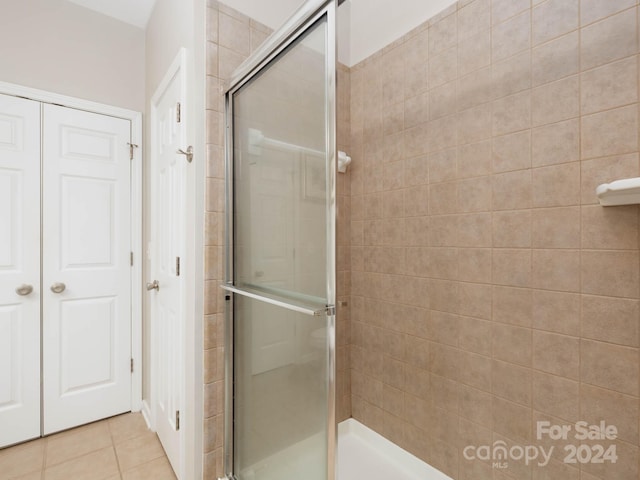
left=0, top=413, right=176, bottom=480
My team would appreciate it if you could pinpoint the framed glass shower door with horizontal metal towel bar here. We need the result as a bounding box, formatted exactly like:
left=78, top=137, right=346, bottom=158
left=223, top=1, right=336, bottom=480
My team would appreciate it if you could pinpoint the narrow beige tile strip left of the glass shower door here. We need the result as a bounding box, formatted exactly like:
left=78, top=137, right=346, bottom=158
left=203, top=0, right=270, bottom=478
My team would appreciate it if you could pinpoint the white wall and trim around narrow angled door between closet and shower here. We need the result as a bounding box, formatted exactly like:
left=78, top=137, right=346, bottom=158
left=143, top=0, right=207, bottom=479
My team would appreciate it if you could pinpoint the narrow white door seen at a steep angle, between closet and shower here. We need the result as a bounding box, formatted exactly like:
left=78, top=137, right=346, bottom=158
left=150, top=67, right=187, bottom=477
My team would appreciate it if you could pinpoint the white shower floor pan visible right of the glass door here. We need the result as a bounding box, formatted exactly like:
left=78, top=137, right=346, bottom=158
left=337, top=418, right=451, bottom=480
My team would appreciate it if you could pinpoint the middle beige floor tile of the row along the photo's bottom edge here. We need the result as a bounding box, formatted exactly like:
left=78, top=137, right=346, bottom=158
left=44, top=447, right=118, bottom=480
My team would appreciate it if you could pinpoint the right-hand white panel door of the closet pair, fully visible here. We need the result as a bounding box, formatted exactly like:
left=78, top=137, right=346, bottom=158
left=42, top=105, right=131, bottom=434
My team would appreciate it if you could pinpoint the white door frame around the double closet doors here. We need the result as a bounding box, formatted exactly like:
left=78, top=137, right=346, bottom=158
left=0, top=81, right=143, bottom=412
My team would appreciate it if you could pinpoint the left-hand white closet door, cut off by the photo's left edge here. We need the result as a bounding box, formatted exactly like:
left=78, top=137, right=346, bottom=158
left=0, top=95, right=40, bottom=447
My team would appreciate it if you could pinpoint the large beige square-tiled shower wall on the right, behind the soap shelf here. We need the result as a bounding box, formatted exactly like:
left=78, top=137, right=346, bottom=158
left=345, top=0, right=640, bottom=480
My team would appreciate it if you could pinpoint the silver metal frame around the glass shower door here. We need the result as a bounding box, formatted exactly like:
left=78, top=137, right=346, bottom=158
left=221, top=0, right=344, bottom=480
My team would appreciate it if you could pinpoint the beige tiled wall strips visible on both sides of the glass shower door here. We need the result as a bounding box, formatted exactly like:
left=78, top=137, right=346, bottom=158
left=204, top=0, right=351, bottom=478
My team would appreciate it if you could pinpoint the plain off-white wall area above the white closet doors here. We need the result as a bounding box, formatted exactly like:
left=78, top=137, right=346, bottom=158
left=0, top=0, right=145, bottom=111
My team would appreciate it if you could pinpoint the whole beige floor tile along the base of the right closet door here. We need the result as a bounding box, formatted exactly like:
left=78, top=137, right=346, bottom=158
left=46, top=422, right=111, bottom=468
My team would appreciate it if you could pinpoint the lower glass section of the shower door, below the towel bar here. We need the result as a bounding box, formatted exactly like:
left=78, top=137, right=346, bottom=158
left=234, top=295, right=328, bottom=480
